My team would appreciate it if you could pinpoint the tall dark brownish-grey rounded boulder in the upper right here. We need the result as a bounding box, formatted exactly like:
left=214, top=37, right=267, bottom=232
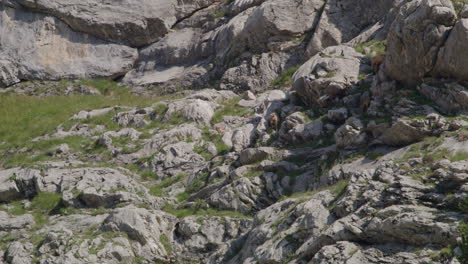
left=385, top=0, right=458, bottom=83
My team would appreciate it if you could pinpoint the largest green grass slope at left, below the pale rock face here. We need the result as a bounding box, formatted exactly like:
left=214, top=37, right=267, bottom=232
left=0, top=80, right=157, bottom=145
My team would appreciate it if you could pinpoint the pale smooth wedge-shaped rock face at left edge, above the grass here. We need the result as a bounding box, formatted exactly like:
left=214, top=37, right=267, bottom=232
left=0, top=6, right=137, bottom=85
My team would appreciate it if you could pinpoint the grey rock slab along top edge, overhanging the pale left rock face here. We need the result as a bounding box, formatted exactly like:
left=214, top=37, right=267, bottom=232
left=14, top=0, right=214, bottom=47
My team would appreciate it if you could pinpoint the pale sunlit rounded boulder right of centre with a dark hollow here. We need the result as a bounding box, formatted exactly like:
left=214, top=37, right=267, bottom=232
left=293, top=46, right=364, bottom=105
